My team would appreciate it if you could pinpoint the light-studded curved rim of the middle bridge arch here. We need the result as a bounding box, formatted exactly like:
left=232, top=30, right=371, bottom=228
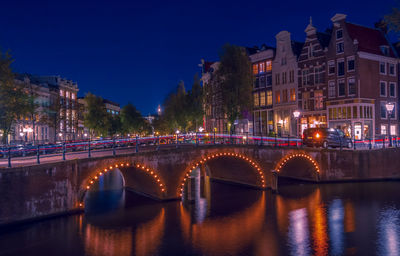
left=177, top=151, right=266, bottom=197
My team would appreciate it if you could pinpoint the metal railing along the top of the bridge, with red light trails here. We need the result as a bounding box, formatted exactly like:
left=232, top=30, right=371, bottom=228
left=0, top=133, right=400, bottom=167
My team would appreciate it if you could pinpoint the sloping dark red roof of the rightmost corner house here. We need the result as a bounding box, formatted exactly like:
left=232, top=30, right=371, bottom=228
left=345, top=22, right=396, bottom=58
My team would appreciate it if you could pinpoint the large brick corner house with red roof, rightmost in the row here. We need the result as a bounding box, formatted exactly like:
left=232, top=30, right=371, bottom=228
left=326, top=14, right=399, bottom=140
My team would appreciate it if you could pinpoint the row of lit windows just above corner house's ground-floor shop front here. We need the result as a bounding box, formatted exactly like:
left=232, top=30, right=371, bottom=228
left=328, top=106, right=373, bottom=120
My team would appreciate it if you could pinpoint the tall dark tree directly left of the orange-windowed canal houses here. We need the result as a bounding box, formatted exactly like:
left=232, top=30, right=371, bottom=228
left=213, top=44, right=253, bottom=132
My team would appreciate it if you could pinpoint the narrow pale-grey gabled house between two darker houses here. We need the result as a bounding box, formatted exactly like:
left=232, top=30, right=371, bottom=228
left=272, top=31, right=303, bottom=136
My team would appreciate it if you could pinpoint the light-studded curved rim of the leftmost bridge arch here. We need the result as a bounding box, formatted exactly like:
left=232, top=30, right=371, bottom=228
left=78, top=162, right=167, bottom=208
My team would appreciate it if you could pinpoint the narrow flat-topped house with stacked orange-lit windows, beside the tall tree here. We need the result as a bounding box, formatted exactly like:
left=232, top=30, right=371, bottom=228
left=248, top=45, right=275, bottom=136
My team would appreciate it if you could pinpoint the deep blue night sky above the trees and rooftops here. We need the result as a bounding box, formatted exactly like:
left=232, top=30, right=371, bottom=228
left=0, top=0, right=396, bottom=114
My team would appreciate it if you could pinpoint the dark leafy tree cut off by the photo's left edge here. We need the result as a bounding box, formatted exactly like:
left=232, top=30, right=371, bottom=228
left=0, top=52, right=29, bottom=144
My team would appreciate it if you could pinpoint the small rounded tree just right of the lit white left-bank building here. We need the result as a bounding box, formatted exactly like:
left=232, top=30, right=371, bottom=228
left=84, top=92, right=111, bottom=135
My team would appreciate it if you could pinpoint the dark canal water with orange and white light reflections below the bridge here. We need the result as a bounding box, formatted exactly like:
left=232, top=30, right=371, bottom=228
left=0, top=179, right=400, bottom=256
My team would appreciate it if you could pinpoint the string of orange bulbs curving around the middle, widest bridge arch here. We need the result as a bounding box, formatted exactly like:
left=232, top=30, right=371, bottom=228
left=178, top=152, right=266, bottom=197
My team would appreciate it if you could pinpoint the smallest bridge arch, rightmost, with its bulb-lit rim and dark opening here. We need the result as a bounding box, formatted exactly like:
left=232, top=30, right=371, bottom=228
left=274, top=152, right=321, bottom=181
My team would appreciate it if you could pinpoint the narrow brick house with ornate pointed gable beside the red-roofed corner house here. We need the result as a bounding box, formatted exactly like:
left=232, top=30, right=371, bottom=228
left=298, top=18, right=330, bottom=134
